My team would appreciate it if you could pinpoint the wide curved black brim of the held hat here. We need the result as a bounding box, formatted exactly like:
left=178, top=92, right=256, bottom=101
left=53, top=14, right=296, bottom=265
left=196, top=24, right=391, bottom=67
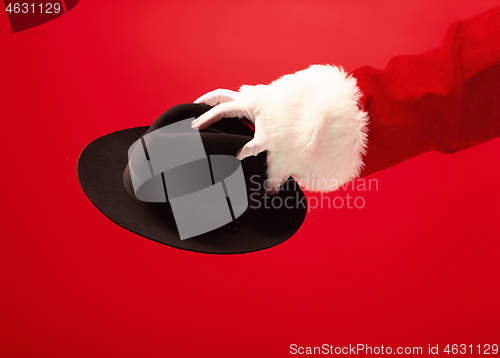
left=77, top=127, right=307, bottom=254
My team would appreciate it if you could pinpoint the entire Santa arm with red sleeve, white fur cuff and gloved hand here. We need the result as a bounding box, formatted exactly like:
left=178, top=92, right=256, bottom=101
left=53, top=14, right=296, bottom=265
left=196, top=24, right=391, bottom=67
left=192, top=7, right=500, bottom=191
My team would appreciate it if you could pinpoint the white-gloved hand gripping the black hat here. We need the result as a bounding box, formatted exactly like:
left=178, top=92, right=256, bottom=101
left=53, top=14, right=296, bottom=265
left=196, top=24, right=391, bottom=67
left=191, top=89, right=268, bottom=160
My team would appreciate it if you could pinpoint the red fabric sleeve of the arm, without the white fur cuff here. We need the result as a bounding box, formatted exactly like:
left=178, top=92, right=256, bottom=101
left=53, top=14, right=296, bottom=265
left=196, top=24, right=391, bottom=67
left=353, top=7, right=500, bottom=176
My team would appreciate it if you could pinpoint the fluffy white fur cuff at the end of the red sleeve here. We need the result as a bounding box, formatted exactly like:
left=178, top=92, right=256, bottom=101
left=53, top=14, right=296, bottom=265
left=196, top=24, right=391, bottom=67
left=240, top=65, right=368, bottom=192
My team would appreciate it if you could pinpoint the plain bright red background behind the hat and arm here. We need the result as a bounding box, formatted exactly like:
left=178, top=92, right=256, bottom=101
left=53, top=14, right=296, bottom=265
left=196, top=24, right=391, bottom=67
left=0, top=0, right=500, bottom=357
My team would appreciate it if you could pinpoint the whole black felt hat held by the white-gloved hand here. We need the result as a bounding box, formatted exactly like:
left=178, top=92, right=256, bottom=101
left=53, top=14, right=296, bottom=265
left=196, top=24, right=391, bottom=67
left=77, top=104, right=307, bottom=254
